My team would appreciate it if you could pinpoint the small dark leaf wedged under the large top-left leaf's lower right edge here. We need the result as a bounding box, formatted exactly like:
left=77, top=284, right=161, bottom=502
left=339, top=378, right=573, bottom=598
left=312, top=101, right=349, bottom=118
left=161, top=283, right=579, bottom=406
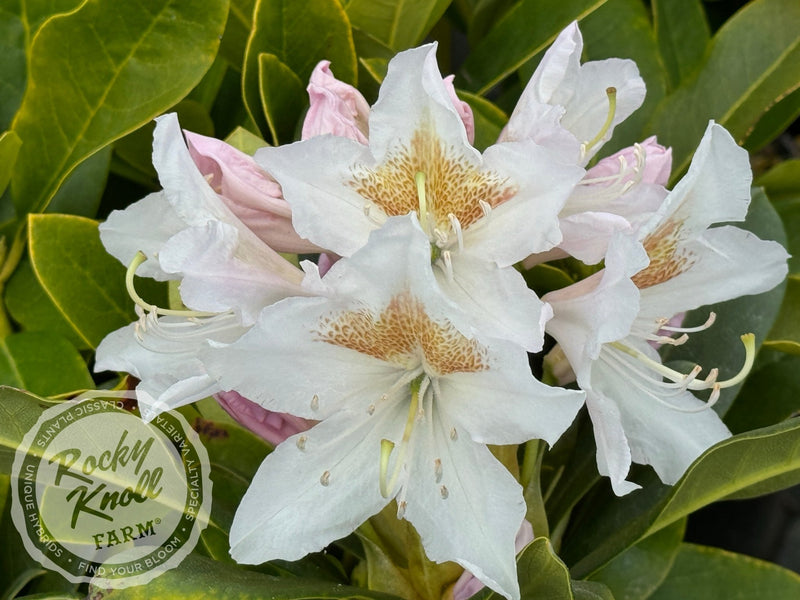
left=47, top=146, right=111, bottom=218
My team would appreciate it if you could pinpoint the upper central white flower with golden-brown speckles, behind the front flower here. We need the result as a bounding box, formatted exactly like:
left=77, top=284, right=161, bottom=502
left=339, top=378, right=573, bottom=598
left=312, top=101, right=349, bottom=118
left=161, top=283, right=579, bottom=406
left=255, top=45, right=584, bottom=350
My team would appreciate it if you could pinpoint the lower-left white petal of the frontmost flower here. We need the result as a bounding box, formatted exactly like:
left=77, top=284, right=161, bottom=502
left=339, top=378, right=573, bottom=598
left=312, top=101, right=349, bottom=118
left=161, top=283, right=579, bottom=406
left=230, top=407, right=404, bottom=564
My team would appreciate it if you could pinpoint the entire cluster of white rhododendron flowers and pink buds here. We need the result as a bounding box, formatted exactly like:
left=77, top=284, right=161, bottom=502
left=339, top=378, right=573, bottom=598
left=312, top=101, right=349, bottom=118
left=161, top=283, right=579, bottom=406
left=97, top=24, right=787, bottom=599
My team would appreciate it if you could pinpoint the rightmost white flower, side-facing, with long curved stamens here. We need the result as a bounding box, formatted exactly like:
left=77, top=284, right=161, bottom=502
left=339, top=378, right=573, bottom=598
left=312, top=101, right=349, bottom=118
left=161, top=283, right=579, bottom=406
left=544, top=123, right=787, bottom=495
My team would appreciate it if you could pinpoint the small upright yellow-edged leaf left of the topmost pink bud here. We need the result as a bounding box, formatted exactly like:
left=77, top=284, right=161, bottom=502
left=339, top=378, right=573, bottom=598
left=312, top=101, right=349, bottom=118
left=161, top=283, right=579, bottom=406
left=258, top=53, right=308, bottom=144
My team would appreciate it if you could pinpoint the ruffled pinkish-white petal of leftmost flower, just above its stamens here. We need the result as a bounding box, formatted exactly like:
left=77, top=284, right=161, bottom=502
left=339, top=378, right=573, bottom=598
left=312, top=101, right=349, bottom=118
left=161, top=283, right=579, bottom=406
left=159, top=221, right=305, bottom=325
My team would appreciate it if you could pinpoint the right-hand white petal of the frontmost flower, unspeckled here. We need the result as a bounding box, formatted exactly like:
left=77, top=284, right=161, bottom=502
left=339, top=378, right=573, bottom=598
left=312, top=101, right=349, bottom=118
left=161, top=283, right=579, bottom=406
left=435, top=342, right=584, bottom=446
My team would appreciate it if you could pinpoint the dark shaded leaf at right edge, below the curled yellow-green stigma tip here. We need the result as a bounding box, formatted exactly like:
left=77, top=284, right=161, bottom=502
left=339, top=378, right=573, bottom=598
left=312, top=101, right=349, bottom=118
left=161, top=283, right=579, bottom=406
left=725, top=350, right=800, bottom=433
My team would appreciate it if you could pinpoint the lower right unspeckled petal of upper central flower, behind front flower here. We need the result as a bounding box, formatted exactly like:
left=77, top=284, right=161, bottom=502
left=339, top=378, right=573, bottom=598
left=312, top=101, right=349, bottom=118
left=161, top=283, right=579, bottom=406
left=435, top=252, right=550, bottom=352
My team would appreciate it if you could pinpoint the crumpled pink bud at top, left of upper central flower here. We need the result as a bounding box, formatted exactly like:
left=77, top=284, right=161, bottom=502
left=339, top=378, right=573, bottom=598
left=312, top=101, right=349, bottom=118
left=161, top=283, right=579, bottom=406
left=302, top=60, right=369, bottom=144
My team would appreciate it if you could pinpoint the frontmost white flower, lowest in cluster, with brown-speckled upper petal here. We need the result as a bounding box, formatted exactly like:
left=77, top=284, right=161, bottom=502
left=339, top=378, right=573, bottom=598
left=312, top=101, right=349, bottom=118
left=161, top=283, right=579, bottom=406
left=203, top=215, right=583, bottom=598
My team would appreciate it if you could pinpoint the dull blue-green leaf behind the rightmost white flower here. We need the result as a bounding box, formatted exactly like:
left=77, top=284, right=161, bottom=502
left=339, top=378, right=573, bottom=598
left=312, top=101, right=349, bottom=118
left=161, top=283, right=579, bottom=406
left=663, top=188, right=786, bottom=415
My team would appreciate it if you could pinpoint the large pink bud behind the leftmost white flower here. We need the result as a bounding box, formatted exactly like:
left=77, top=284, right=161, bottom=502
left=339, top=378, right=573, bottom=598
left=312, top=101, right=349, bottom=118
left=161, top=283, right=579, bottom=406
left=184, top=131, right=320, bottom=252
